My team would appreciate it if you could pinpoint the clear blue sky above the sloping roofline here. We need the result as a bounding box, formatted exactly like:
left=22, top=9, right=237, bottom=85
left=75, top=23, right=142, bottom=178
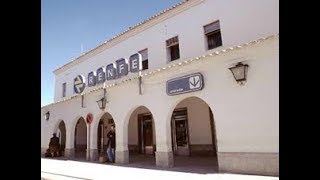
left=41, top=0, right=183, bottom=106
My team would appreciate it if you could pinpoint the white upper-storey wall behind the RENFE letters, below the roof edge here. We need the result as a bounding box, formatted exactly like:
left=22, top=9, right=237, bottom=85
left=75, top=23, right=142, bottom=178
left=55, top=0, right=279, bottom=102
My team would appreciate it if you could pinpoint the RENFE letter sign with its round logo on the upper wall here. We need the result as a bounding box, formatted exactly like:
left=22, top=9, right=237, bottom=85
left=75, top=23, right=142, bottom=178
left=73, top=53, right=142, bottom=94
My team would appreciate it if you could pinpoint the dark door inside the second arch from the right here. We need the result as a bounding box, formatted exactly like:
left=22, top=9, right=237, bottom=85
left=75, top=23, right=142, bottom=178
left=139, top=114, right=154, bottom=154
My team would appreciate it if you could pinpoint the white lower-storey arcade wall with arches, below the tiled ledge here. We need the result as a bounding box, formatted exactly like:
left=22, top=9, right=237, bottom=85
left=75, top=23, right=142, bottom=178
left=41, top=37, right=279, bottom=153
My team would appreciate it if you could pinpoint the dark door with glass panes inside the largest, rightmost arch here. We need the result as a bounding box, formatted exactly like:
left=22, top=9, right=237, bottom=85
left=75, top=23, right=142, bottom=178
left=172, top=108, right=190, bottom=156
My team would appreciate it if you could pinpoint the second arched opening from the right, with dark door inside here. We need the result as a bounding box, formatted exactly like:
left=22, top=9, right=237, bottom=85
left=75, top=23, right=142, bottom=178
left=128, top=106, right=156, bottom=165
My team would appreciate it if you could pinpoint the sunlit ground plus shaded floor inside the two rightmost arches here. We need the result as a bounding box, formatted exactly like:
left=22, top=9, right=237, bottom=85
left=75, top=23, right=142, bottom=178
left=41, top=156, right=279, bottom=180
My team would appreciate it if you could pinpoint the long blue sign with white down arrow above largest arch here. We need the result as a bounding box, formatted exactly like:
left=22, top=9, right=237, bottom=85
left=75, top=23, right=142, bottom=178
left=167, top=73, right=204, bottom=96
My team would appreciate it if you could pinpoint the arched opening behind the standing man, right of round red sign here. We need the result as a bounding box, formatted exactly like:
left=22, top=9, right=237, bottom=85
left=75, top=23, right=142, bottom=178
left=97, top=113, right=115, bottom=160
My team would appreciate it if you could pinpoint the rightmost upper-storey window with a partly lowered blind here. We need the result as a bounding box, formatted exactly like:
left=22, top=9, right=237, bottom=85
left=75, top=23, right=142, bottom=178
left=204, top=21, right=222, bottom=50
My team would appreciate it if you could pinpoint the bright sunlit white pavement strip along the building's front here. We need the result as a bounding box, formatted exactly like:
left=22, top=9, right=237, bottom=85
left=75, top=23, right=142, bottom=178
left=41, top=158, right=279, bottom=180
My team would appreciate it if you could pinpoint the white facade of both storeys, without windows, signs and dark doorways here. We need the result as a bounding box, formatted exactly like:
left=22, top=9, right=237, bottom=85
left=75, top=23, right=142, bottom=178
left=41, top=0, right=279, bottom=175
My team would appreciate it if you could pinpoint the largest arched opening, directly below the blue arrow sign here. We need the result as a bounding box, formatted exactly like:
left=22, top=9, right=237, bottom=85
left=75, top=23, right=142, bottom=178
left=170, top=96, right=218, bottom=172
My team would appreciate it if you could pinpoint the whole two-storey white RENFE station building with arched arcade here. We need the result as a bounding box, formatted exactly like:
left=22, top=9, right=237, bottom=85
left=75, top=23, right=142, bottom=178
left=41, top=0, right=279, bottom=175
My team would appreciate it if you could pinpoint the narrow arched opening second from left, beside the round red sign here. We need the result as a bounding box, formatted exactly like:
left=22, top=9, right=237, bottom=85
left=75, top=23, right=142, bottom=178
left=74, top=117, right=87, bottom=159
